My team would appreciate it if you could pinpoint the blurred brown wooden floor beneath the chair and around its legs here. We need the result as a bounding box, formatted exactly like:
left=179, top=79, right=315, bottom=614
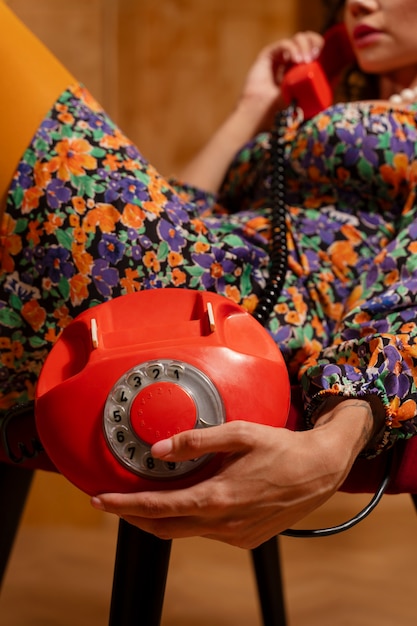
left=0, top=486, right=417, bottom=626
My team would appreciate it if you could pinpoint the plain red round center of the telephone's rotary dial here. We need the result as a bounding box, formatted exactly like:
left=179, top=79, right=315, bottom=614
left=130, top=382, right=197, bottom=445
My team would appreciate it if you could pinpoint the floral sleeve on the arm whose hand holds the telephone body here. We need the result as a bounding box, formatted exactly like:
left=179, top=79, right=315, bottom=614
left=302, top=179, right=417, bottom=451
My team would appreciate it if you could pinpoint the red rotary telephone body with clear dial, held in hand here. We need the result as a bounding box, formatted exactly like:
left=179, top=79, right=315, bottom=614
left=35, top=289, right=290, bottom=495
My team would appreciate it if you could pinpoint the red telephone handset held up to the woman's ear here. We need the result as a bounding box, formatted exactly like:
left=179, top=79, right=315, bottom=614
left=281, top=23, right=355, bottom=119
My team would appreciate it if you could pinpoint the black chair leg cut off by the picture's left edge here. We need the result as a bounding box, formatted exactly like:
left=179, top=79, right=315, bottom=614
left=0, top=463, right=34, bottom=585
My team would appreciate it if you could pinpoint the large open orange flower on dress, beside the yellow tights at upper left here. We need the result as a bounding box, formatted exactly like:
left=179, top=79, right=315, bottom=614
left=49, top=138, right=97, bottom=181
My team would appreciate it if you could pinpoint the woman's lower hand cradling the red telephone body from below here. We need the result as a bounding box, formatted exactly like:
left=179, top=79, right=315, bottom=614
left=92, top=399, right=374, bottom=548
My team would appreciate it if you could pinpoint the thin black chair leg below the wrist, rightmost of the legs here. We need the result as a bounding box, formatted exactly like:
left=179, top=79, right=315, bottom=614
left=251, top=537, right=287, bottom=626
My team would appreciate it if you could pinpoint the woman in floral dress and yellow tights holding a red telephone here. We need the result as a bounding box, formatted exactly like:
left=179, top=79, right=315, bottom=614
left=0, top=0, right=417, bottom=548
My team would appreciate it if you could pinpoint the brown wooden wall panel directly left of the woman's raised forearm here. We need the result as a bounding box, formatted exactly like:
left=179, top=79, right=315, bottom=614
left=119, top=0, right=295, bottom=173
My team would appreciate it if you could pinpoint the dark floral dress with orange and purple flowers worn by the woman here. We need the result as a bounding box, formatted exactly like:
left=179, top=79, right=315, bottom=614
left=0, top=85, right=417, bottom=454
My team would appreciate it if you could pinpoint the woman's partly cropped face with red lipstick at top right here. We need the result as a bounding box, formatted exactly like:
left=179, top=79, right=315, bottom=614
left=344, top=0, right=417, bottom=82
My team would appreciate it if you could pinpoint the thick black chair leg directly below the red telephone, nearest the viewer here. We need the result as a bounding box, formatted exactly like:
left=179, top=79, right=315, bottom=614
left=109, top=520, right=172, bottom=626
